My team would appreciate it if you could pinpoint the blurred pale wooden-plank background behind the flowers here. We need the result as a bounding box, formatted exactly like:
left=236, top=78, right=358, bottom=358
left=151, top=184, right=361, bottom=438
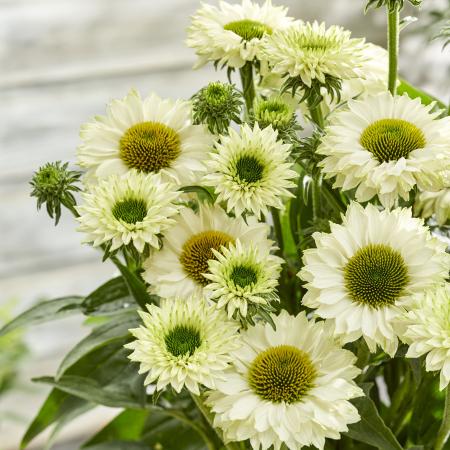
left=0, top=0, right=450, bottom=450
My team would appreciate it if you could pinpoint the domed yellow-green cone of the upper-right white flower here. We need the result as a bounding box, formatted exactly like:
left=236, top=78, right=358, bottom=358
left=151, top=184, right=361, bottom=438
left=360, top=119, right=426, bottom=162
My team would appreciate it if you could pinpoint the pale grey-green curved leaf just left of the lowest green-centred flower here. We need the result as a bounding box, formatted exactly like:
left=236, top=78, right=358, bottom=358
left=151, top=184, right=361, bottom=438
left=55, top=311, right=139, bottom=380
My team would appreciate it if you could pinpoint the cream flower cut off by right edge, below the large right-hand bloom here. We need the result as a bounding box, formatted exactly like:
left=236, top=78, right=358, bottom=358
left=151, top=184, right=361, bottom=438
left=401, top=283, right=450, bottom=390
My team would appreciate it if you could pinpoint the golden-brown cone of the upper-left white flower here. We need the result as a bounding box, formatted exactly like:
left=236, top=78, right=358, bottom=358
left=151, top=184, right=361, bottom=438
left=119, top=122, right=180, bottom=173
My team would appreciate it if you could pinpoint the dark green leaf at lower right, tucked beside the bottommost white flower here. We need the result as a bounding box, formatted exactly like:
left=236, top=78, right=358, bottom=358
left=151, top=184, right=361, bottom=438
left=345, top=384, right=403, bottom=450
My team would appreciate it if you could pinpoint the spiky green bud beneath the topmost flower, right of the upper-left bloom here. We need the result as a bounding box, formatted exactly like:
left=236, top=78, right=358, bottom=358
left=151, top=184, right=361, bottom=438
left=192, top=81, right=242, bottom=134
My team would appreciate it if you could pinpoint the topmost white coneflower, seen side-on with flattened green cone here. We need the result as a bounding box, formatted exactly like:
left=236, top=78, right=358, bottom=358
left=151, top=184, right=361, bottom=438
left=186, top=0, right=293, bottom=68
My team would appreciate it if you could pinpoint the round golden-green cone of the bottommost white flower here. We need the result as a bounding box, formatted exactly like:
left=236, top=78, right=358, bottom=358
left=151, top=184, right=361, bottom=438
left=248, top=345, right=316, bottom=403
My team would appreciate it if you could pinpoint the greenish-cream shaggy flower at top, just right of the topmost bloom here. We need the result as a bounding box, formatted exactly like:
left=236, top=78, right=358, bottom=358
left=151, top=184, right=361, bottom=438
left=262, top=22, right=365, bottom=87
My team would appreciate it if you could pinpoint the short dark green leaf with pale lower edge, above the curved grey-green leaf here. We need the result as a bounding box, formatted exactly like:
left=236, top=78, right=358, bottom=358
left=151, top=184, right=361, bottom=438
left=81, top=277, right=135, bottom=316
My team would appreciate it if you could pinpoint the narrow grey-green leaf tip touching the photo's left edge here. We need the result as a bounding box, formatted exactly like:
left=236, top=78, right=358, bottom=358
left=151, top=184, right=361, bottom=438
left=0, top=296, right=83, bottom=336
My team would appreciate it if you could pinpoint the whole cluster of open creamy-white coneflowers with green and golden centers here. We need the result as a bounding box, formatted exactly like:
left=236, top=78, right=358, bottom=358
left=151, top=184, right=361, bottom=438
left=65, top=0, right=450, bottom=450
